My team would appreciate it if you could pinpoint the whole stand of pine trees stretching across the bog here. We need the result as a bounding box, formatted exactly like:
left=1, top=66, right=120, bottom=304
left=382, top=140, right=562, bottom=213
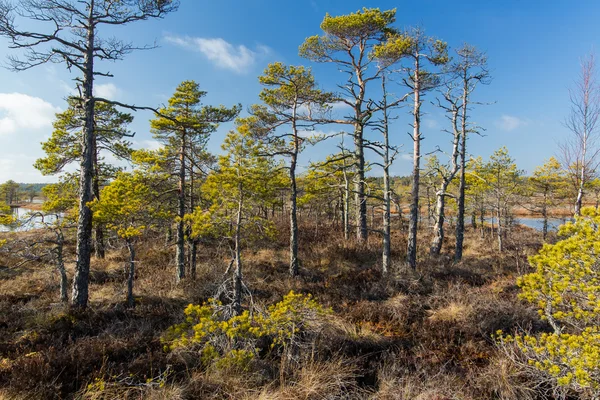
left=0, top=0, right=591, bottom=322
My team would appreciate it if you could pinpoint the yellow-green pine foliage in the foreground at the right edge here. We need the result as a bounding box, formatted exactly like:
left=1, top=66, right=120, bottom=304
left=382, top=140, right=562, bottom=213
left=503, top=208, right=600, bottom=393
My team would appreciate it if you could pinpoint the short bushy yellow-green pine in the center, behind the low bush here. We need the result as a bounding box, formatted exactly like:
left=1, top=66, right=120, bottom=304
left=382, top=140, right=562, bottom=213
left=191, top=125, right=287, bottom=315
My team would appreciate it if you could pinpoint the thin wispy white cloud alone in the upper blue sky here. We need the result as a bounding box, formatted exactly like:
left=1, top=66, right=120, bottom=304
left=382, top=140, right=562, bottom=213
left=165, top=36, right=271, bottom=73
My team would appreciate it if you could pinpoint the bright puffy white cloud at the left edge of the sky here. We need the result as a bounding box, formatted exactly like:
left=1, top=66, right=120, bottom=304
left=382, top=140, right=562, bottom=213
left=0, top=93, right=60, bottom=135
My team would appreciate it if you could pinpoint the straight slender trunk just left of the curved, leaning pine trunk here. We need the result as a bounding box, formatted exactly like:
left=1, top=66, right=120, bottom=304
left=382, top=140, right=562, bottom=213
left=406, top=61, right=421, bottom=269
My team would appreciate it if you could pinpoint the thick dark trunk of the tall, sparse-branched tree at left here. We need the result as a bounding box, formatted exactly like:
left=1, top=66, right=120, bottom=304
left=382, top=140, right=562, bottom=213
left=71, top=0, right=95, bottom=308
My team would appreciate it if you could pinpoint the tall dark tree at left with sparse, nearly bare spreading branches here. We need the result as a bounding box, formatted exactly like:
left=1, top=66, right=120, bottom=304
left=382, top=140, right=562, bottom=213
left=0, top=0, right=179, bottom=308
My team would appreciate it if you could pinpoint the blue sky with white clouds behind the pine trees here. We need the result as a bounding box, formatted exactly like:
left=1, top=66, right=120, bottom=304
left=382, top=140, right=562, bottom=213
left=0, top=0, right=600, bottom=182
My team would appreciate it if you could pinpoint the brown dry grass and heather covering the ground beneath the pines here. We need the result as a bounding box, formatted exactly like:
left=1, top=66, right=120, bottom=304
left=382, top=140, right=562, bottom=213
left=0, top=226, right=546, bottom=400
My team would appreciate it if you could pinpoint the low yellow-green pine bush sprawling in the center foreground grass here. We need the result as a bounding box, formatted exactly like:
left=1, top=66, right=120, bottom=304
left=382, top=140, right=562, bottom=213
left=163, top=291, right=330, bottom=369
